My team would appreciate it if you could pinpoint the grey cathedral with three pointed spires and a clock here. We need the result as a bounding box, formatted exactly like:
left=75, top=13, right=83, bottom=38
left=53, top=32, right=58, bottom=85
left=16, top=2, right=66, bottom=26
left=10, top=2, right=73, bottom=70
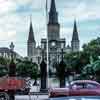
left=27, top=0, right=80, bottom=69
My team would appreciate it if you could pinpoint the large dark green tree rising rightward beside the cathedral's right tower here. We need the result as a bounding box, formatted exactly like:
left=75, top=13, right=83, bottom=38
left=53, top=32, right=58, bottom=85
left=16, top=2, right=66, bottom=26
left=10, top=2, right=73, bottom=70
left=65, top=38, right=100, bottom=73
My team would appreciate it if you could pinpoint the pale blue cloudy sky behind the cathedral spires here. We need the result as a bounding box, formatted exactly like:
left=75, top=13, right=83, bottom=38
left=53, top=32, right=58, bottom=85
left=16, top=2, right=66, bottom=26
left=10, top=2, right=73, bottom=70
left=0, top=0, right=100, bottom=56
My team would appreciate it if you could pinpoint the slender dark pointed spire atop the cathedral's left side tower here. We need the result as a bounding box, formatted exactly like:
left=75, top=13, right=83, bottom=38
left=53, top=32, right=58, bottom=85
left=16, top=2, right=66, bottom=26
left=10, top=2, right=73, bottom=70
left=28, top=16, right=35, bottom=42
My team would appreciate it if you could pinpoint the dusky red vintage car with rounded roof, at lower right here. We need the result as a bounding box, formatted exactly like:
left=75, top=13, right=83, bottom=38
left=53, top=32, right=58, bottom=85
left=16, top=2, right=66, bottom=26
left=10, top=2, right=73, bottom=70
left=49, top=80, right=100, bottom=97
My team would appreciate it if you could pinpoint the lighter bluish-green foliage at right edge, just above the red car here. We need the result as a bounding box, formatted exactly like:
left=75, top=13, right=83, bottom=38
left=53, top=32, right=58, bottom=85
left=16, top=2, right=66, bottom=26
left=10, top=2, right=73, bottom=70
left=78, top=60, right=100, bottom=82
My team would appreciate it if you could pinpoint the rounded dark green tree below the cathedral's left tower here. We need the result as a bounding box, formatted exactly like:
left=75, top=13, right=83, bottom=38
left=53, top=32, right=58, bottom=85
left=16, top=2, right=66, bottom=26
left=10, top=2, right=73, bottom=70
left=17, top=60, right=39, bottom=79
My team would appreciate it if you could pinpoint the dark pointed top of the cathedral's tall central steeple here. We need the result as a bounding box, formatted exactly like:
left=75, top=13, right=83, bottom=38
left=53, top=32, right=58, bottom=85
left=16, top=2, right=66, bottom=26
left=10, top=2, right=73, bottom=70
left=49, top=0, right=58, bottom=24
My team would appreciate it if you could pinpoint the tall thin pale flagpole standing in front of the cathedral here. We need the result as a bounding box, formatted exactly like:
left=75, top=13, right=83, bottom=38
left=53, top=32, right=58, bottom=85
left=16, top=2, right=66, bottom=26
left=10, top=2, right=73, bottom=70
left=46, top=0, right=49, bottom=88
